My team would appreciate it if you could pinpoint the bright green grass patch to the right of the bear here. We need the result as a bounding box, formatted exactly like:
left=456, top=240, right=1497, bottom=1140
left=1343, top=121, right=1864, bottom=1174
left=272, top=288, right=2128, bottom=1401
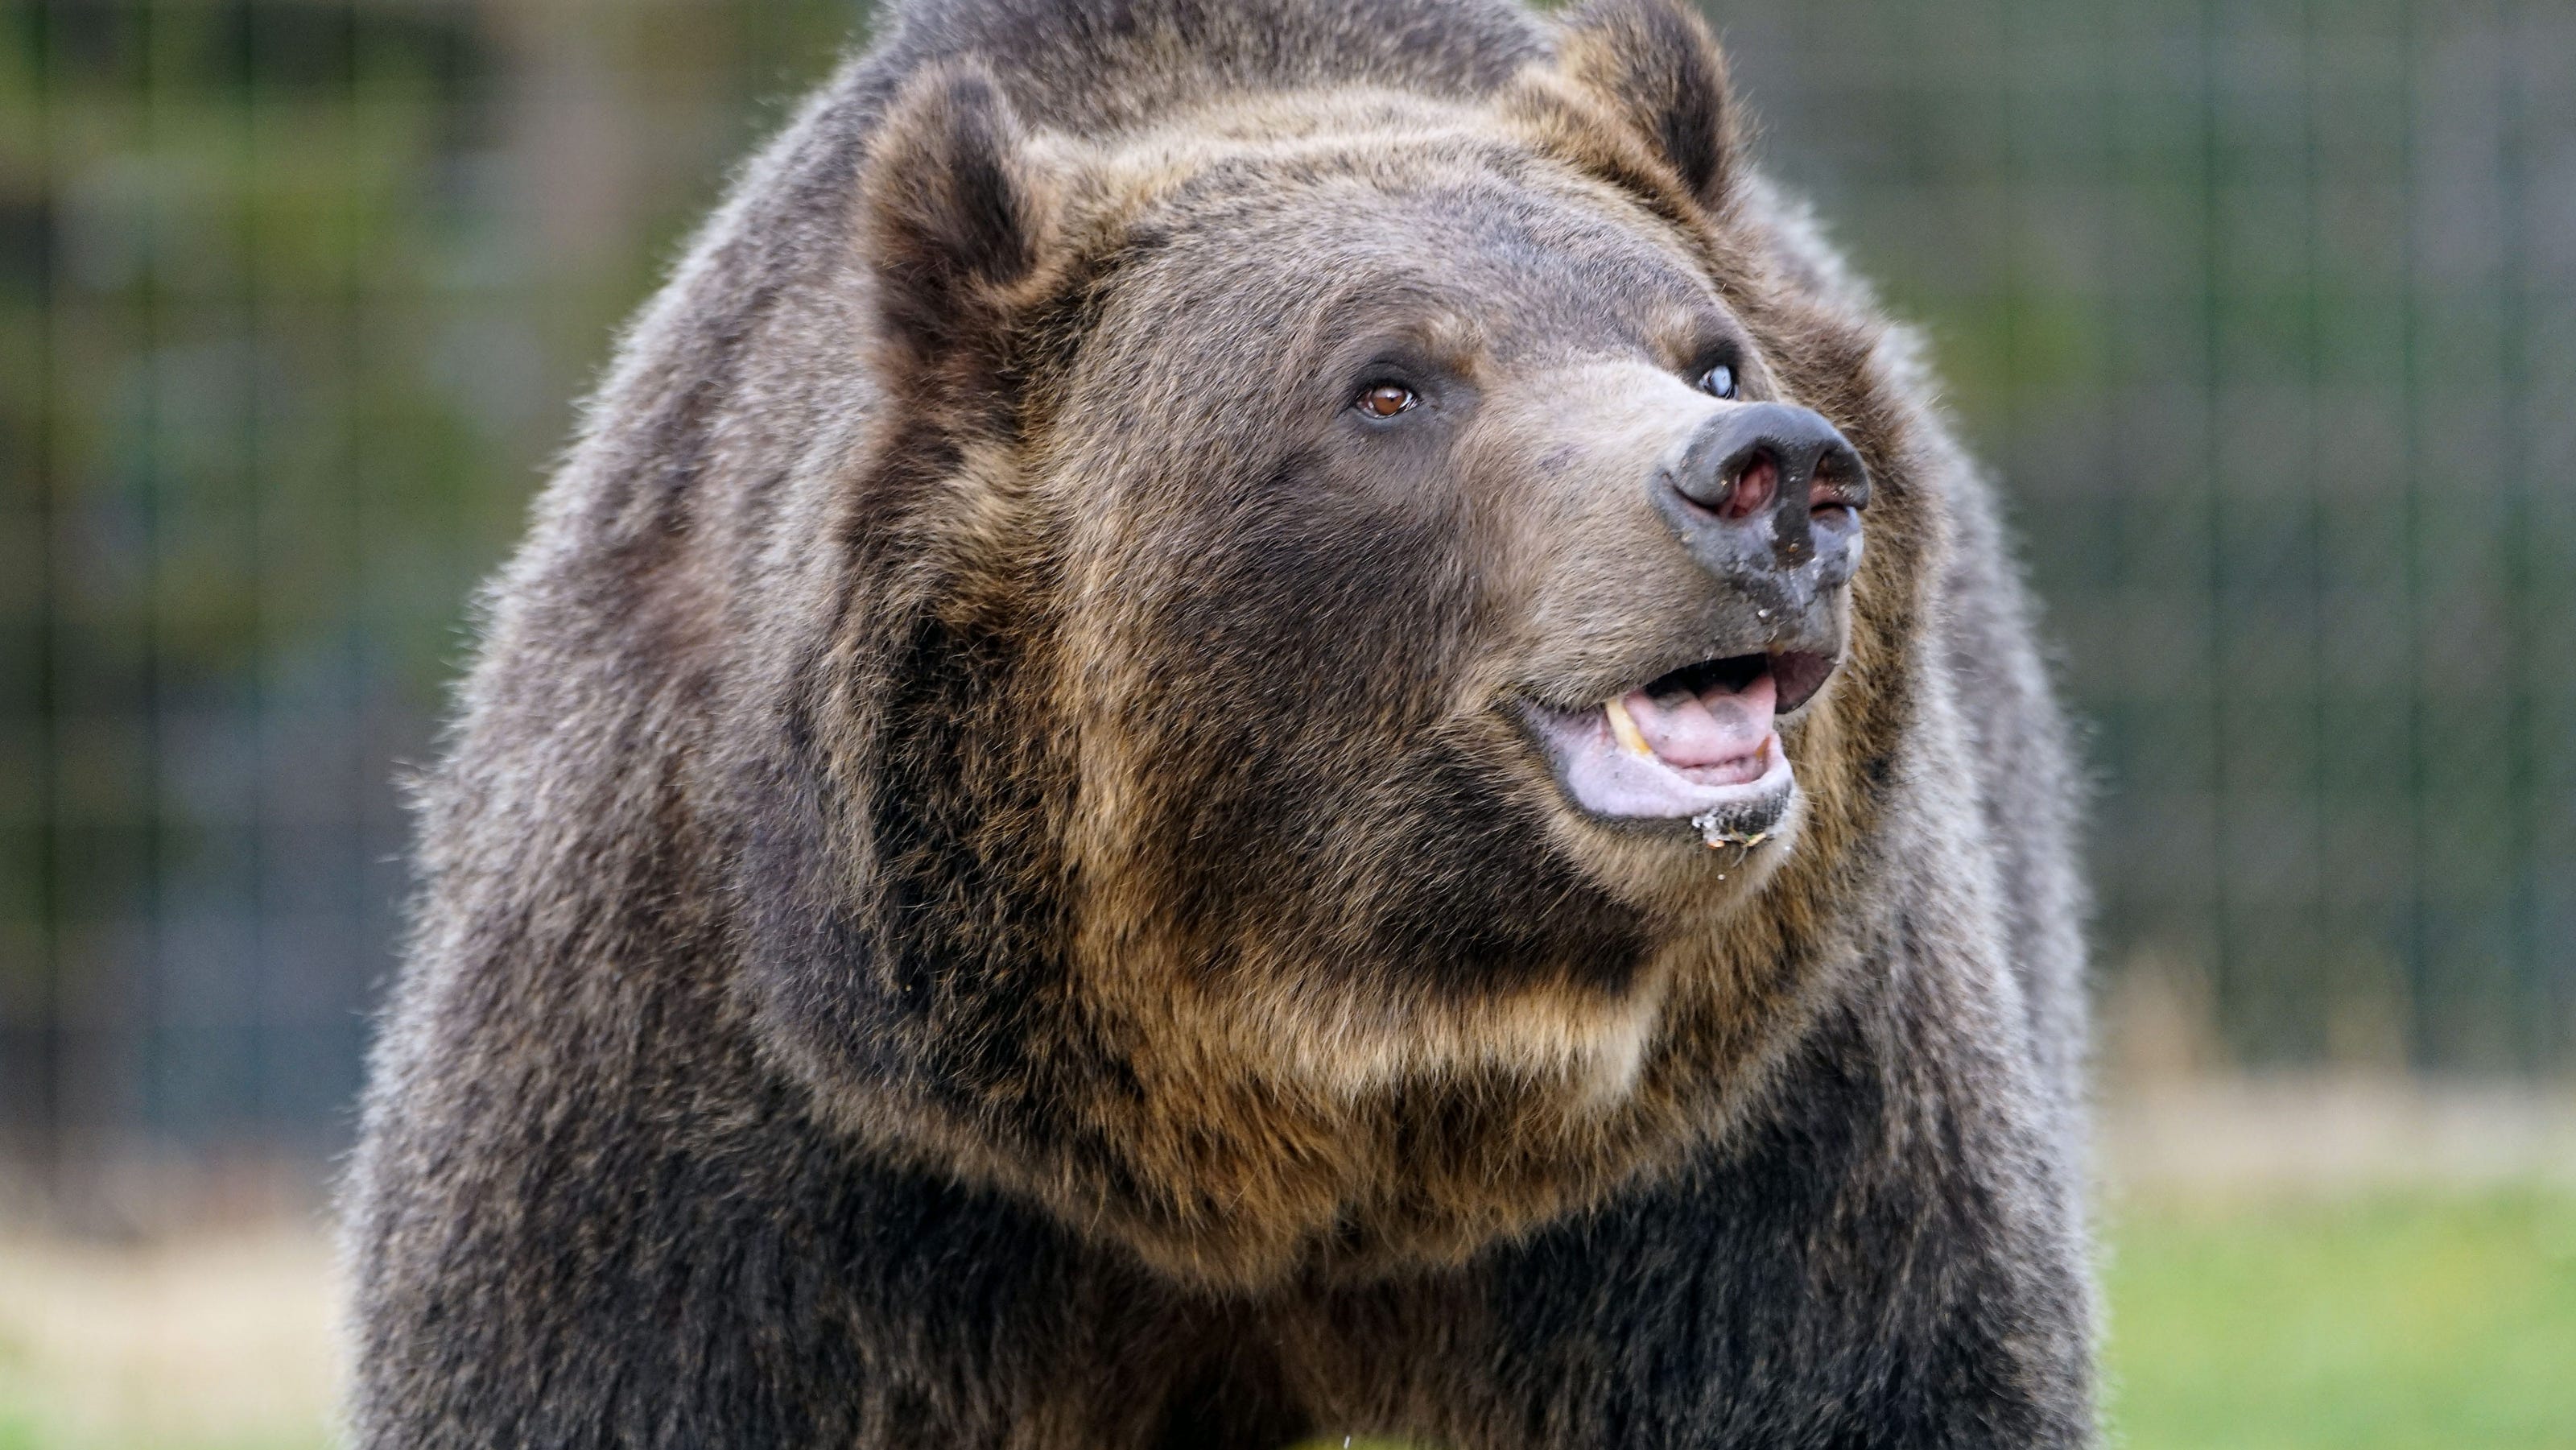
left=2102, top=1192, right=2576, bottom=1450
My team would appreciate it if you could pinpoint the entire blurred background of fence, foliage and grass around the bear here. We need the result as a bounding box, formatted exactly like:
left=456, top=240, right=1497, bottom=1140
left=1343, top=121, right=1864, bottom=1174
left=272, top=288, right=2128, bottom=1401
left=0, top=0, right=2576, bottom=1450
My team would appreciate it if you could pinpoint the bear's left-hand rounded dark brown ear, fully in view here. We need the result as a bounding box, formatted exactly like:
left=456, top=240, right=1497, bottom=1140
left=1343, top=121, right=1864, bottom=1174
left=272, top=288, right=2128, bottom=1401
left=861, top=64, right=1051, bottom=363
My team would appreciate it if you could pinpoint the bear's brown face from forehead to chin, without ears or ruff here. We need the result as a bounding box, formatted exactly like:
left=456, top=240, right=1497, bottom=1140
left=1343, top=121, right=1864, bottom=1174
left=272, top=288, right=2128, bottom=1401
left=1033, top=108, right=1868, bottom=1079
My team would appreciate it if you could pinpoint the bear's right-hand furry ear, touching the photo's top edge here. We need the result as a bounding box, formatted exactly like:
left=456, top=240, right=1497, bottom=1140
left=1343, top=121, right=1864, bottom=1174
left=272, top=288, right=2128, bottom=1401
left=1554, top=0, right=1736, bottom=211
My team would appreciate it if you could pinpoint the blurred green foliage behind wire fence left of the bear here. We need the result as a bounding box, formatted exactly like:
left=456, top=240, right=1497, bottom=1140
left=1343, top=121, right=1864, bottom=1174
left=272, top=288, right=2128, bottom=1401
left=0, top=0, right=865, bottom=1133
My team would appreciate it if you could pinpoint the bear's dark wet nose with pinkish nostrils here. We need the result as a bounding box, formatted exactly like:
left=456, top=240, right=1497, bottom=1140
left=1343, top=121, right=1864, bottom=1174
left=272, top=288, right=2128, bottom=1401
left=1653, top=402, right=1870, bottom=587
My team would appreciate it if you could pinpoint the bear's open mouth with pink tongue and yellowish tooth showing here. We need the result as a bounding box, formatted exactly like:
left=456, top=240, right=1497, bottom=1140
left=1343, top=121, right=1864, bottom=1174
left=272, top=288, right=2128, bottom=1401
left=1528, top=651, right=1834, bottom=842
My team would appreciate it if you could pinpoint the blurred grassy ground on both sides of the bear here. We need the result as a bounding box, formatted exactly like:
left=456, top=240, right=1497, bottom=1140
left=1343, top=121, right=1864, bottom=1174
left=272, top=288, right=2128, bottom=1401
left=0, top=1190, right=2576, bottom=1450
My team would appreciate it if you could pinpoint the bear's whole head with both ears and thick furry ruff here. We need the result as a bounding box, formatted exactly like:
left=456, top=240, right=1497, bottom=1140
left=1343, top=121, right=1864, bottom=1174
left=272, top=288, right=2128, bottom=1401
left=729, top=0, right=1937, bottom=1285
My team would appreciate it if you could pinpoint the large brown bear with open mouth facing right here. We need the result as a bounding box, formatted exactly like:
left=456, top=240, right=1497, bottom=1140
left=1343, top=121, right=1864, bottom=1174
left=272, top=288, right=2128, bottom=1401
left=348, top=0, right=2091, bottom=1450
